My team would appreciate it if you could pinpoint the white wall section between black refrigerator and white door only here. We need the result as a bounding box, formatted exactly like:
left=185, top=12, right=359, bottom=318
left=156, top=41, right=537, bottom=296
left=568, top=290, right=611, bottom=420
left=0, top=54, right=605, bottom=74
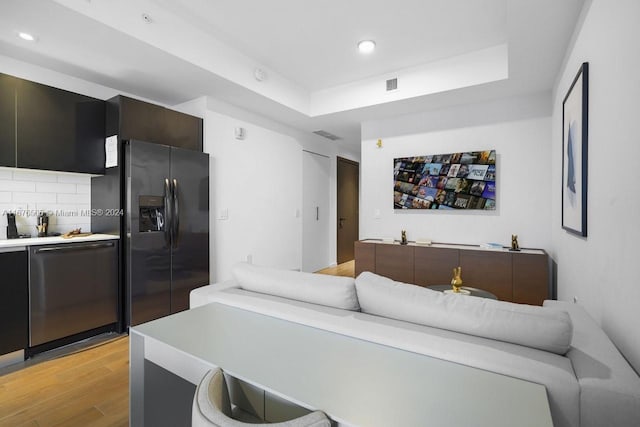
left=205, top=111, right=302, bottom=277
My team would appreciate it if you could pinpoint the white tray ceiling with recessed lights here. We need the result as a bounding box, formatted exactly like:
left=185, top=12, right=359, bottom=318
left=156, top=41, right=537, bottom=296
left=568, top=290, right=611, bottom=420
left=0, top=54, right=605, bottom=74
left=0, top=0, right=584, bottom=145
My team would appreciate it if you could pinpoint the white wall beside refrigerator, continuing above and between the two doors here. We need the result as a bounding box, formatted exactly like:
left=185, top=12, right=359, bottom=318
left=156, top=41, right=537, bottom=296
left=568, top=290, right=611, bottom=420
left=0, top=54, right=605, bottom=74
left=184, top=98, right=359, bottom=281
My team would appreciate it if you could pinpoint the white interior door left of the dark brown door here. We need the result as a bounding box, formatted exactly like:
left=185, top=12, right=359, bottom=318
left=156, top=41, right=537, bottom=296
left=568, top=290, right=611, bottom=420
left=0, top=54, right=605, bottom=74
left=302, top=151, right=331, bottom=272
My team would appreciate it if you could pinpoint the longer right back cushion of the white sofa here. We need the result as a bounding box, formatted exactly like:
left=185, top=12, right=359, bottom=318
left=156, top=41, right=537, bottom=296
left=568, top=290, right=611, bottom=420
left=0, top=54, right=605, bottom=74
left=356, top=272, right=572, bottom=354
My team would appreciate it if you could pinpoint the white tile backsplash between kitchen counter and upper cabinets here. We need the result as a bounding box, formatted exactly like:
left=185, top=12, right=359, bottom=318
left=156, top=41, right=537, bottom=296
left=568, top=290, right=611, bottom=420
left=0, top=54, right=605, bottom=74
left=0, top=168, right=91, bottom=239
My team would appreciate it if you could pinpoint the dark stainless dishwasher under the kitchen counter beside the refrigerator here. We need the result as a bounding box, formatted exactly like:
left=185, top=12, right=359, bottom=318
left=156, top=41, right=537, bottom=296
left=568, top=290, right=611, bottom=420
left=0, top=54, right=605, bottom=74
left=29, top=241, right=118, bottom=347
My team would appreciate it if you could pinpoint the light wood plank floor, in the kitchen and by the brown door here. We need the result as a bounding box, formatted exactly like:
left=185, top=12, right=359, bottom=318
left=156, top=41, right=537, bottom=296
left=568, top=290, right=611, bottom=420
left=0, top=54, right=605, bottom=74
left=0, top=261, right=354, bottom=427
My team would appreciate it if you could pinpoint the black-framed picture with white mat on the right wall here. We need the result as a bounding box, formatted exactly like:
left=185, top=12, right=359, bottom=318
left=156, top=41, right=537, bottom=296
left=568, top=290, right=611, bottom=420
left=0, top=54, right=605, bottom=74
left=562, top=62, right=589, bottom=237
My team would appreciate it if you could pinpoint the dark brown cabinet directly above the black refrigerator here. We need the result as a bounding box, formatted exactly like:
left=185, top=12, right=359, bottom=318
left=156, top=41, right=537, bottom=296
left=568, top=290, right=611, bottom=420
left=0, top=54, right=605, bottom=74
left=107, top=96, right=202, bottom=151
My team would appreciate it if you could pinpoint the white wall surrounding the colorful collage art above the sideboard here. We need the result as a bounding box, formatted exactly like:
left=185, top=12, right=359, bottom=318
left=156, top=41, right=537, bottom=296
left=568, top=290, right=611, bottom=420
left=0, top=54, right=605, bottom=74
left=360, top=94, right=551, bottom=249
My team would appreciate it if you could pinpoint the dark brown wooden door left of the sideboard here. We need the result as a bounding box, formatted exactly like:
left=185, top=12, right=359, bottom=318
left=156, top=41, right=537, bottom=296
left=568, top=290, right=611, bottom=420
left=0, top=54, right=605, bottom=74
left=337, top=157, right=360, bottom=264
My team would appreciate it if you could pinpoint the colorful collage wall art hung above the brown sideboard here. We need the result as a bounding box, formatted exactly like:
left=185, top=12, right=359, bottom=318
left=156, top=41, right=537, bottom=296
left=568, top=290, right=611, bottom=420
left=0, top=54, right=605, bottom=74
left=393, top=150, right=496, bottom=210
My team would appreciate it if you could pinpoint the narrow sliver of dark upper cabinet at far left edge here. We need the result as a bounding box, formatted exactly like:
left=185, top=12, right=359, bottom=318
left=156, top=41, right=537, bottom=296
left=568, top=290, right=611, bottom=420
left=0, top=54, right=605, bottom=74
left=0, top=74, right=18, bottom=166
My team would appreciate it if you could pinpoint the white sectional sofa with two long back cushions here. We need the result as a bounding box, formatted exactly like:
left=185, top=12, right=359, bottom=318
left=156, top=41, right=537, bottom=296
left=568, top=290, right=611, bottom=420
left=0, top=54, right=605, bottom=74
left=190, top=264, right=640, bottom=427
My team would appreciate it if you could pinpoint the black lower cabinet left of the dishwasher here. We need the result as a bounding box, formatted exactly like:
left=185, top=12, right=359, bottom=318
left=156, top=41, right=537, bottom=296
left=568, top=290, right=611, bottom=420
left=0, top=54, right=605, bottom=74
left=0, top=249, right=29, bottom=355
